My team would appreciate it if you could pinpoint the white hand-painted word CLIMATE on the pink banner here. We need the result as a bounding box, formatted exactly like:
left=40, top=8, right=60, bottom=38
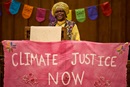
left=12, top=52, right=58, bottom=66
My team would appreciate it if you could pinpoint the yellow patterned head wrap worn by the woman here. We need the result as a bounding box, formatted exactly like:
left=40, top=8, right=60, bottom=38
left=52, top=2, right=69, bottom=16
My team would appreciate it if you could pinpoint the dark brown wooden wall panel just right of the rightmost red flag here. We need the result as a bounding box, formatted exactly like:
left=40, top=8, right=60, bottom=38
left=111, top=0, right=126, bottom=42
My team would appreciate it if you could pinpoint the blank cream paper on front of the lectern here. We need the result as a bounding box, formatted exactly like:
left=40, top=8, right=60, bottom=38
left=30, top=26, right=61, bottom=42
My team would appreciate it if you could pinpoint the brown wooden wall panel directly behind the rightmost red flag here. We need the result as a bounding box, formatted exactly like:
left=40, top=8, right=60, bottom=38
left=97, top=0, right=111, bottom=42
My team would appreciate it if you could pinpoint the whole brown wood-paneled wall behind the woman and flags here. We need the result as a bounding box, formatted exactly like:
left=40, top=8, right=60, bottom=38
left=0, top=0, right=130, bottom=54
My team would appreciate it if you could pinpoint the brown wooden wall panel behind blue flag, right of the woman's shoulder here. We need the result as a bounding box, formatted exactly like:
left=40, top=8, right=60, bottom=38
left=77, top=0, right=98, bottom=41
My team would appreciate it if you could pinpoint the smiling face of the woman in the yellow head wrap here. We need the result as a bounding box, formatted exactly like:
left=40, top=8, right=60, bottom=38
left=55, top=8, right=66, bottom=21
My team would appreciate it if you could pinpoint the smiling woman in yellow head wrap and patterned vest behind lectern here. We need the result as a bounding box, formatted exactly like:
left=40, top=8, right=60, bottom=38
left=49, top=2, right=80, bottom=41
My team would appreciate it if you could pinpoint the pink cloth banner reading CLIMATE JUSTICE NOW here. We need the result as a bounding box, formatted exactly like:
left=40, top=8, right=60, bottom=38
left=2, top=41, right=128, bottom=87
